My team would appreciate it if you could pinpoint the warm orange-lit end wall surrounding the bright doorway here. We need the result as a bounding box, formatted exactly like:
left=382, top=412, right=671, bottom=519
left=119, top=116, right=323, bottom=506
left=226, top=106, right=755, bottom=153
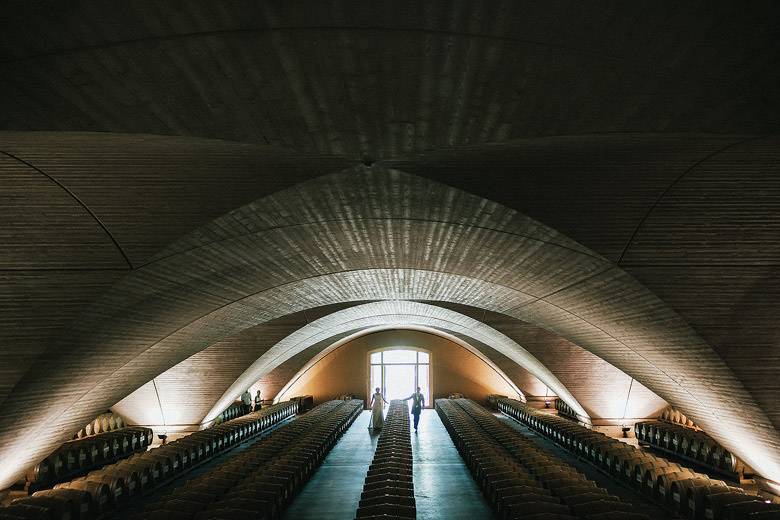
left=277, top=330, right=517, bottom=402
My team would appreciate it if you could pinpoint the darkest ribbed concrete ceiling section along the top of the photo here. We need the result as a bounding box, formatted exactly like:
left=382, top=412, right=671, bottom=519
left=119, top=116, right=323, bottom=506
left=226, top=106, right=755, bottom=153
left=0, top=0, right=780, bottom=154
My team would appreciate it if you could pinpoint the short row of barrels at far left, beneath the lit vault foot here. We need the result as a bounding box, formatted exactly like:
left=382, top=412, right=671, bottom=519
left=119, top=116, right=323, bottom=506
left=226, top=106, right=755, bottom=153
left=26, top=426, right=152, bottom=491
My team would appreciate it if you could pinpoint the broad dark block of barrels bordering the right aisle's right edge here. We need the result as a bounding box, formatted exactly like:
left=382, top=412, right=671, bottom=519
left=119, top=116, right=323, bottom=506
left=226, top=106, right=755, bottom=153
left=436, top=399, right=649, bottom=520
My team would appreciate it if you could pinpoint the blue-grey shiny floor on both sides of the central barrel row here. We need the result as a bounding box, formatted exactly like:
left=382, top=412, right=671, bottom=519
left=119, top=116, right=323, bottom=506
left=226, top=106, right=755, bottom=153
left=282, top=410, right=494, bottom=520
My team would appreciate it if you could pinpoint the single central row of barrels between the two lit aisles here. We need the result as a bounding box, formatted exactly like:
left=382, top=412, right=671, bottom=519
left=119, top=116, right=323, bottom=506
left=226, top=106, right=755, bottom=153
left=357, top=400, right=417, bottom=518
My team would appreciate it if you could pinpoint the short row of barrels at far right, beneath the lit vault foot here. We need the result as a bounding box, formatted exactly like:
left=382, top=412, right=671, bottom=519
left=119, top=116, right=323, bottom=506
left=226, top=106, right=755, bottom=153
left=634, top=421, right=752, bottom=476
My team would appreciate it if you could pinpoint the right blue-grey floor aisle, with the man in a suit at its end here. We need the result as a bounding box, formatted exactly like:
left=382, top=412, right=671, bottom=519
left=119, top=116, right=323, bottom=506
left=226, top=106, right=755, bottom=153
left=412, top=410, right=494, bottom=520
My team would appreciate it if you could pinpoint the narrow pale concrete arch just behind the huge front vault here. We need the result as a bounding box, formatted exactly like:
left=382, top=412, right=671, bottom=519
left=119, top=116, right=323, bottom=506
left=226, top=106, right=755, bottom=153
left=203, top=300, right=588, bottom=422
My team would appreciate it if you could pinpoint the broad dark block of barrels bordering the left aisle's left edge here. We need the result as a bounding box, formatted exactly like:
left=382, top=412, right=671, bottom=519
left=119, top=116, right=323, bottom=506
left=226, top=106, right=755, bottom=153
left=137, top=400, right=363, bottom=519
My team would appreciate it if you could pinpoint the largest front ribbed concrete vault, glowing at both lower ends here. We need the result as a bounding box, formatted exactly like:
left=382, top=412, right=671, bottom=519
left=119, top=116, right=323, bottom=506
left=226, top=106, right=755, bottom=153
left=0, top=166, right=780, bottom=487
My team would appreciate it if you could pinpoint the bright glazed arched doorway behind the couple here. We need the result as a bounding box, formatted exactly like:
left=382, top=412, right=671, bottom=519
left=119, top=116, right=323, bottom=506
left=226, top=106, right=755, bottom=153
left=367, top=347, right=431, bottom=407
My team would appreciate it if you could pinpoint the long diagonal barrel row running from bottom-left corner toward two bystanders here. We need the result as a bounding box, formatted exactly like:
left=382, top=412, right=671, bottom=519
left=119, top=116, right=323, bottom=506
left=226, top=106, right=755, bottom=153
left=0, top=402, right=298, bottom=519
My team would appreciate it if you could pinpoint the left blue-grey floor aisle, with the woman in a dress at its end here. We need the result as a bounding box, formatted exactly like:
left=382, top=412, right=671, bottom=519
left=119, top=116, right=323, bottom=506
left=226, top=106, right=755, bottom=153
left=282, top=411, right=378, bottom=520
